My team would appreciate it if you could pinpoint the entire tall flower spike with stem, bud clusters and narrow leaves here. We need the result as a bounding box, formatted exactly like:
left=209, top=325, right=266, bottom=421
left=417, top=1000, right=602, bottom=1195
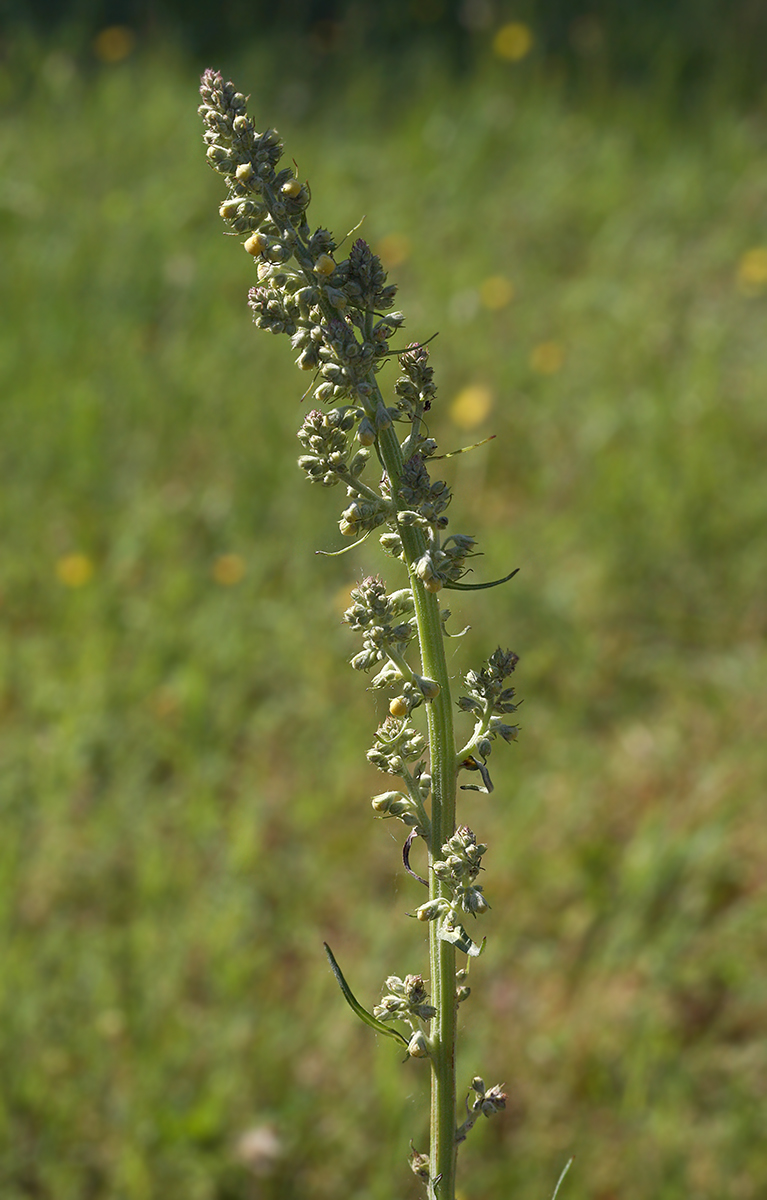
left=200, top=71, right=517, bottom=1200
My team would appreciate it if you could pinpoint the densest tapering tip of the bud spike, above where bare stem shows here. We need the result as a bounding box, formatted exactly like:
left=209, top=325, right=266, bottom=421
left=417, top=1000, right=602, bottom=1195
left=199, top=71, right=405, bottom=432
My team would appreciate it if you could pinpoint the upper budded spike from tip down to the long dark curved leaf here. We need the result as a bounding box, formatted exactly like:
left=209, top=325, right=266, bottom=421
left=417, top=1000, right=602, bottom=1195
left=199, top=71, right=484, bottom=580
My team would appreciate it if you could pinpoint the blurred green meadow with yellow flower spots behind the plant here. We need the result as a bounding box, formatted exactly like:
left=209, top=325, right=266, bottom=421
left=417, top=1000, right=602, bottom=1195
left=0, top=0, right=767, bottom=1200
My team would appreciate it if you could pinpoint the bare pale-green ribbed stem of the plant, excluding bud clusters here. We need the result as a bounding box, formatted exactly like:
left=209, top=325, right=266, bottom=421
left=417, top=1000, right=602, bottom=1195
left=378, top=428, right=457, bottom=1200
